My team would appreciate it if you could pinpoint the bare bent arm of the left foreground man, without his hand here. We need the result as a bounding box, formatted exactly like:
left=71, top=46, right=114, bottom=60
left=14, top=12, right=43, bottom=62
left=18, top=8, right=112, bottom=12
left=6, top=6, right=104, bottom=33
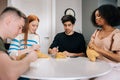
left=0, top=53, right=30, bottom=80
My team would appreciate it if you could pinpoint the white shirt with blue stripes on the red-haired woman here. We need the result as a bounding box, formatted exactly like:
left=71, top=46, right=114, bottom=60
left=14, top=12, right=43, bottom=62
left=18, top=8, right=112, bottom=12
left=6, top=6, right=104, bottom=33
left=8, top=33, right=40, bottom=55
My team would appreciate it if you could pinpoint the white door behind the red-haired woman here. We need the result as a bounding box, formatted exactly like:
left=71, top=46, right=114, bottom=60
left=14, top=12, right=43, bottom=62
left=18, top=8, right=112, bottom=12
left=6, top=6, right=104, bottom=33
left=9, top=0, right=52, bottom=53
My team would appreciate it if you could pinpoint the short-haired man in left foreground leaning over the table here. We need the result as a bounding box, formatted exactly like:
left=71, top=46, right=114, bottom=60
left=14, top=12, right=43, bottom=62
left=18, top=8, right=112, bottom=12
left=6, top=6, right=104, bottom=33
left=0, top=7, right=38, bottom=80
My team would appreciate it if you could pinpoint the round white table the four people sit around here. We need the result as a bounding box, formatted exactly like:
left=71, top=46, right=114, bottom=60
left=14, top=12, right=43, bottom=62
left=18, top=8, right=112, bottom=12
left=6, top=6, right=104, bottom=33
left=22, top=57, right=111, bottom=80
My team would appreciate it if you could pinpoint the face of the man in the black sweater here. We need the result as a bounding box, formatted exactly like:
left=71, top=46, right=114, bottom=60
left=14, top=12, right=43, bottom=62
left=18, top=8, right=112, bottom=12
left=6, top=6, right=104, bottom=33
left=63, top=21, right=74, bottom=35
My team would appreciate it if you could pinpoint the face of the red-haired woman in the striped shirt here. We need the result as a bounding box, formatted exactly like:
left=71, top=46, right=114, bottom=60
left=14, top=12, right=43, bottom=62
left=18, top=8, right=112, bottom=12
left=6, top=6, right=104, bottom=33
left=29, top=20, right=39, bottom=34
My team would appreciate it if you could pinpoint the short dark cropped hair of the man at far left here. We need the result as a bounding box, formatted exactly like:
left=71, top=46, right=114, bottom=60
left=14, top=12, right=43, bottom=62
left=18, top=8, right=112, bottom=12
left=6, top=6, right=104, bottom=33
left=0, top=7, right=26, bottom=20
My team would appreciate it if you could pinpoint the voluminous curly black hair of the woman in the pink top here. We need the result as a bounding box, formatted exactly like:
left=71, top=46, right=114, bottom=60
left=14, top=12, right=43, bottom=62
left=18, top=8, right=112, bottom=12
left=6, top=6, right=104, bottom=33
left=91, top=4, right=120, bottom=27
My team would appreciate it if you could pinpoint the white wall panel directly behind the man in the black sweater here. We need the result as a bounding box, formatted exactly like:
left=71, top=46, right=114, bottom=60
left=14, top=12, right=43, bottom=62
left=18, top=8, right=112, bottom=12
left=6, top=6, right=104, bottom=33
left=56, top=0, right=82, bottom=33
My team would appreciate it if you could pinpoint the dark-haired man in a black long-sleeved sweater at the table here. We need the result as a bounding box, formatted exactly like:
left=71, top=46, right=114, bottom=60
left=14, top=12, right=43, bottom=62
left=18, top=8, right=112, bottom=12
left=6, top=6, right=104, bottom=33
left=48, top=15, right=86, bottom=57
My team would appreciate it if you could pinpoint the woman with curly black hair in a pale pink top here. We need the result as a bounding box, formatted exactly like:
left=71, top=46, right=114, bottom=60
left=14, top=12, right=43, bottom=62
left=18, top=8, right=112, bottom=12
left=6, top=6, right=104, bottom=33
left=88, top=4, right=120, bottom=80
